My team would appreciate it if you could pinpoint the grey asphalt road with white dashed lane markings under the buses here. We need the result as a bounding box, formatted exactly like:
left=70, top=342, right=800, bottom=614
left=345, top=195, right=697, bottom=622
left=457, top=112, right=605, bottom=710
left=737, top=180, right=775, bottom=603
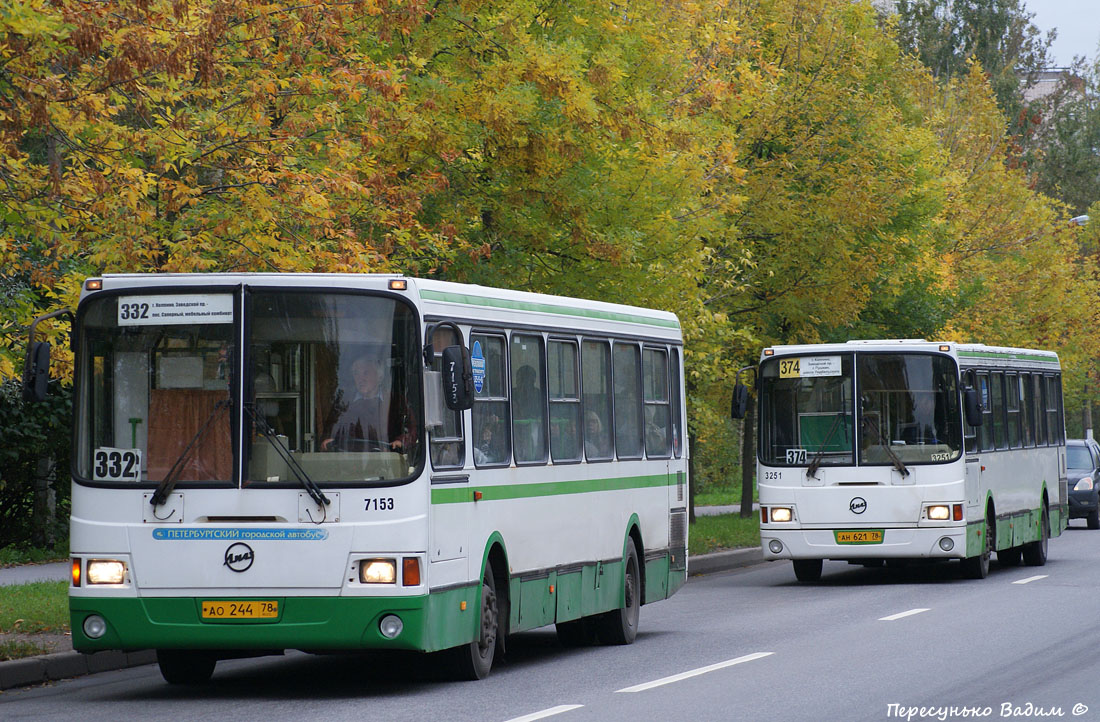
left=0, top=526, right=1100, bottom=722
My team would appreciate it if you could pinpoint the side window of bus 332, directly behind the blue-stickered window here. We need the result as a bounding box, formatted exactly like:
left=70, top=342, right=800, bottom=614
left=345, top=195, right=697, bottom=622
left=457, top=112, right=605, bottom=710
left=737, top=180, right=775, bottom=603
left=512, top=333, right=547, bottom=463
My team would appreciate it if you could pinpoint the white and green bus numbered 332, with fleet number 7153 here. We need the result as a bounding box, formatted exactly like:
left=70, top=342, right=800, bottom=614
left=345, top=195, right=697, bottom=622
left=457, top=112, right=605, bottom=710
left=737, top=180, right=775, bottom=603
left=26, top=274, right=688, bottom=682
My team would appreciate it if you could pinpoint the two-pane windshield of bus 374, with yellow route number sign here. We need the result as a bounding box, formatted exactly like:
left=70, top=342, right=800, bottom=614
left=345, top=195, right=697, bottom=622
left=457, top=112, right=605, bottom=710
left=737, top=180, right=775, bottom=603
left=760, top=353, right=963, bottom=466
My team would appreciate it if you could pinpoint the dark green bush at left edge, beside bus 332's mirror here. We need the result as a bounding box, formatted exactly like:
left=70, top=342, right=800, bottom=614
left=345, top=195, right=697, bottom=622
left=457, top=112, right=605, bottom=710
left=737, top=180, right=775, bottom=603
left=0, top=380, right=72, bottom=547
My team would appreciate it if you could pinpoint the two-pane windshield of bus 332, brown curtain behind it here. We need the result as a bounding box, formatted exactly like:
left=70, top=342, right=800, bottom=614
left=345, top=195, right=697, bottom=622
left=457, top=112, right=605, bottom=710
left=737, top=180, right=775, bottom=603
left=75, top=291, right=422, bottom=484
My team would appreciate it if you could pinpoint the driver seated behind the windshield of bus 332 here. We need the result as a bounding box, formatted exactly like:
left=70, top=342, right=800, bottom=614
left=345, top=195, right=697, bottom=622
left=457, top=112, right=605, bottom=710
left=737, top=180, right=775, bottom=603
left=321, top=355, right=416, bottom=453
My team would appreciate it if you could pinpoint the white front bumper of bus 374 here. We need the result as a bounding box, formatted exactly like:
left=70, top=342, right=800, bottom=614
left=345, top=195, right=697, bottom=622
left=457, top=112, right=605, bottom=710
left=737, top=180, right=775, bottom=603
left=760, top=526, right=967, bottom=560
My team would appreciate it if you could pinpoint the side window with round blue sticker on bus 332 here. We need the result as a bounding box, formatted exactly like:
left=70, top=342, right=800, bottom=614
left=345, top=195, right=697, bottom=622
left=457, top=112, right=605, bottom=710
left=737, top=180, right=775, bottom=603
left=470, top=333, right=512, bottom=466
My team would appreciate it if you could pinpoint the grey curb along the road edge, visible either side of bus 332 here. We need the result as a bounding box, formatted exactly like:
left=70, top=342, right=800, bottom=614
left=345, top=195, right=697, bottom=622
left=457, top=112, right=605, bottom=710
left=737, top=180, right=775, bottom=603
left=0, top=547, right=763, bottom=690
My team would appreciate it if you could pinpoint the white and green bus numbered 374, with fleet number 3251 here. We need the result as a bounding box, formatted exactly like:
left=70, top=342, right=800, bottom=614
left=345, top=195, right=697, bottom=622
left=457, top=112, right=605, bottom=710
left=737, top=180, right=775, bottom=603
left=734, top=340, right=1068, bottom=581
